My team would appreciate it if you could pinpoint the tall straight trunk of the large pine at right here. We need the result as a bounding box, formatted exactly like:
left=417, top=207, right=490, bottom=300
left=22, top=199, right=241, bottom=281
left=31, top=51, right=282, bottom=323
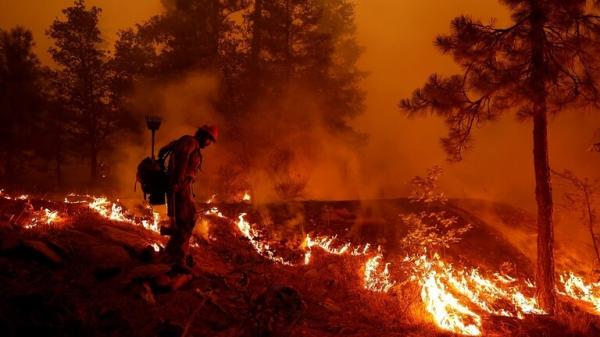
left=530, top=0, right=556, bottom=315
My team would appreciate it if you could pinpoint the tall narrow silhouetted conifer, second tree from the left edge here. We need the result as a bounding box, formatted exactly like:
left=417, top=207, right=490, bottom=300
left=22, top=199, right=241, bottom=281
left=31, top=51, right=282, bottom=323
left=47, top=0, right=116, bottom=184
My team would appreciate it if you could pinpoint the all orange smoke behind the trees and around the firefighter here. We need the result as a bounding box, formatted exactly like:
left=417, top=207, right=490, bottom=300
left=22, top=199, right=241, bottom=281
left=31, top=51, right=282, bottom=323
left=0, top=0, right=600, bottom=210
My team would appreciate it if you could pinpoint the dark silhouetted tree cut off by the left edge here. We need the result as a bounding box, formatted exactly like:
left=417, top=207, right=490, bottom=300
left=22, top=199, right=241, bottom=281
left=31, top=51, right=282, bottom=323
left=0, top=27, right=44, bottom=184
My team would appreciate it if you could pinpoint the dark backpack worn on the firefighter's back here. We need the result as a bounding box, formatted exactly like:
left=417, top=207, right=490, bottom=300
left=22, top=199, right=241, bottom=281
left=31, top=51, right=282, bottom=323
left=136, top=157, right=169, bottom=205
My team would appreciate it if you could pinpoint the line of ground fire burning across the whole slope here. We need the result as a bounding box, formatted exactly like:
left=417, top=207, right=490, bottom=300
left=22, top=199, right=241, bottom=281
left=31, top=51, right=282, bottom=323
left=1, top=193, right=600, bottom=336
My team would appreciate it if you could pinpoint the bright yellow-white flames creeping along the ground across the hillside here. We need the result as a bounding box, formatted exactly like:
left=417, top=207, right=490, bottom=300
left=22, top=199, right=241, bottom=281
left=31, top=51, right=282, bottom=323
left=0, top=190, right=600, bottom=336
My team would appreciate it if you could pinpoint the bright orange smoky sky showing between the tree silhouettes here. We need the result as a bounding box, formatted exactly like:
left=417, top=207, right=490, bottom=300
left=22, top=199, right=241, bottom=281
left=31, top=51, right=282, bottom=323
left=0, top=0, right=600, bottom=208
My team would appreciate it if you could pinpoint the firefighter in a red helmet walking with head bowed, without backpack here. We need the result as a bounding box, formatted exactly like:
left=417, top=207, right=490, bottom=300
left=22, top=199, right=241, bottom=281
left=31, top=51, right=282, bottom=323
left=158, top=125, right=218, bottom=269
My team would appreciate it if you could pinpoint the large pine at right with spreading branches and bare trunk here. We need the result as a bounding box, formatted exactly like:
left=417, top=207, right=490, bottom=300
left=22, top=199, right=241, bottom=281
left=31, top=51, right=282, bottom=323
left=400, top=0, right=600, bottom=314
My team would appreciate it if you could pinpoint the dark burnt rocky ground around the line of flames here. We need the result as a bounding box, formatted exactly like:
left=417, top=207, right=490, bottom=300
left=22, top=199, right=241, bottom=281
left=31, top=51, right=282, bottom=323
left=0, top=199, right=600, bottom=337
